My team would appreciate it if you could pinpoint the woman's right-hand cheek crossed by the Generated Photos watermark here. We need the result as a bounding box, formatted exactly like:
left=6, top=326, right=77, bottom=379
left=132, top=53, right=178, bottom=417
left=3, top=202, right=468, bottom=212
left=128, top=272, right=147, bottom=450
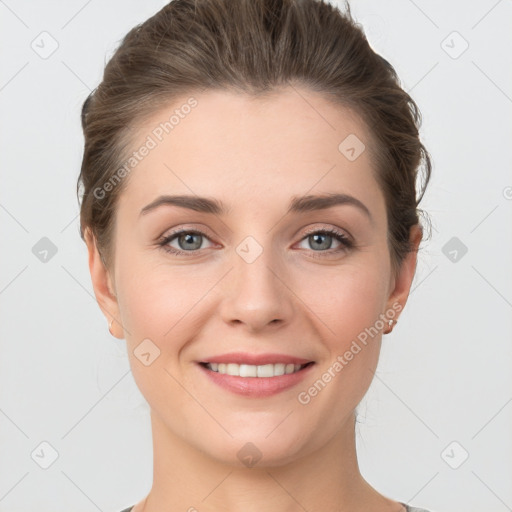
left=297, top=260, right=387, bottom=416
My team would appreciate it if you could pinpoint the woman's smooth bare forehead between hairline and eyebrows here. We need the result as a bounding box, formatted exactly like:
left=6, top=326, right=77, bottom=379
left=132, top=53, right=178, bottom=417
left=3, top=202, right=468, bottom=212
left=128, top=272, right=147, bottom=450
left=119, top=87, right=383, bottom=222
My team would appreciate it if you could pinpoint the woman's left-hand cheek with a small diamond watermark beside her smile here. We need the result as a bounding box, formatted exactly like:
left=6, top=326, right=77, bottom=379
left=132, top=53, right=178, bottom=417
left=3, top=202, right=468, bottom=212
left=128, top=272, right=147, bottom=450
left=115, top=260, right=198, bottom=411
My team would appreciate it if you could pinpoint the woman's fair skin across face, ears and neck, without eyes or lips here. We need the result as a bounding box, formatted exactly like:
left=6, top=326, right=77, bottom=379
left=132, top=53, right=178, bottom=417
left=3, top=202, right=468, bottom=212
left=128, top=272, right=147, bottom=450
left=87, top=87, right=421, bottom=512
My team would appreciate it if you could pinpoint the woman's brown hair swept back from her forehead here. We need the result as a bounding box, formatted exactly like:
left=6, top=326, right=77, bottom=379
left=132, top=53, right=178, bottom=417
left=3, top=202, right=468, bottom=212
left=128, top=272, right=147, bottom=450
left=77, top=0, right=431, bottom=271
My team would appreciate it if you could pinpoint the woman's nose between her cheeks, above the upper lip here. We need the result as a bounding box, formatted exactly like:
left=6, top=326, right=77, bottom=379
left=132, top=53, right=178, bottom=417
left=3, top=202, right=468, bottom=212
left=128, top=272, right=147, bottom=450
left=220, top=242, right=294, bottom=333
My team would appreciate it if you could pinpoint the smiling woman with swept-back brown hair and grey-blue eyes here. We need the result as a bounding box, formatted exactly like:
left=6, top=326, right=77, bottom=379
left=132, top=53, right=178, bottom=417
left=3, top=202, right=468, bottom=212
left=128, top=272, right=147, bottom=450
left=79, top=0, right=431, bottom=512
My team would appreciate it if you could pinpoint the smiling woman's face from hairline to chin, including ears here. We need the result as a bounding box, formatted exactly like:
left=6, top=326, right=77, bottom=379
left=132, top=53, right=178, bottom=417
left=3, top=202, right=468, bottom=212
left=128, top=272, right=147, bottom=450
left=85, top=88, right=419, bottom=466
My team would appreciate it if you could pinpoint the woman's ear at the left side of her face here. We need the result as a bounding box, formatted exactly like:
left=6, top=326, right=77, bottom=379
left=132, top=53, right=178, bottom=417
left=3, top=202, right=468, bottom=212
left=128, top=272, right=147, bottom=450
left=84, top=228, right=123, bottom=339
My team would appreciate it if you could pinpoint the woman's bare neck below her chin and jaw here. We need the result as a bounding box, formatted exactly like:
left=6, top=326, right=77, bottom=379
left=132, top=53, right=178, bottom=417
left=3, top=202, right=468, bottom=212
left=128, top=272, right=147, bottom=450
left=138, top=412, right=403, bottom=512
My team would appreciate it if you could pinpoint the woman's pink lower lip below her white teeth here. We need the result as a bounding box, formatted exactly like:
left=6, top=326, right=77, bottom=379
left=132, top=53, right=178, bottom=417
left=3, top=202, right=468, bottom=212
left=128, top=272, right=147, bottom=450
left=198, top=364, right=315, bottom=398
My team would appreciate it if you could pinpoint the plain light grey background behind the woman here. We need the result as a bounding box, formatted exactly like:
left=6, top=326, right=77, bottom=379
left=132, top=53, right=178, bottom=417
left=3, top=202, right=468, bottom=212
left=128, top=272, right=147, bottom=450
left=0, top=0, right=512, bottom=512
